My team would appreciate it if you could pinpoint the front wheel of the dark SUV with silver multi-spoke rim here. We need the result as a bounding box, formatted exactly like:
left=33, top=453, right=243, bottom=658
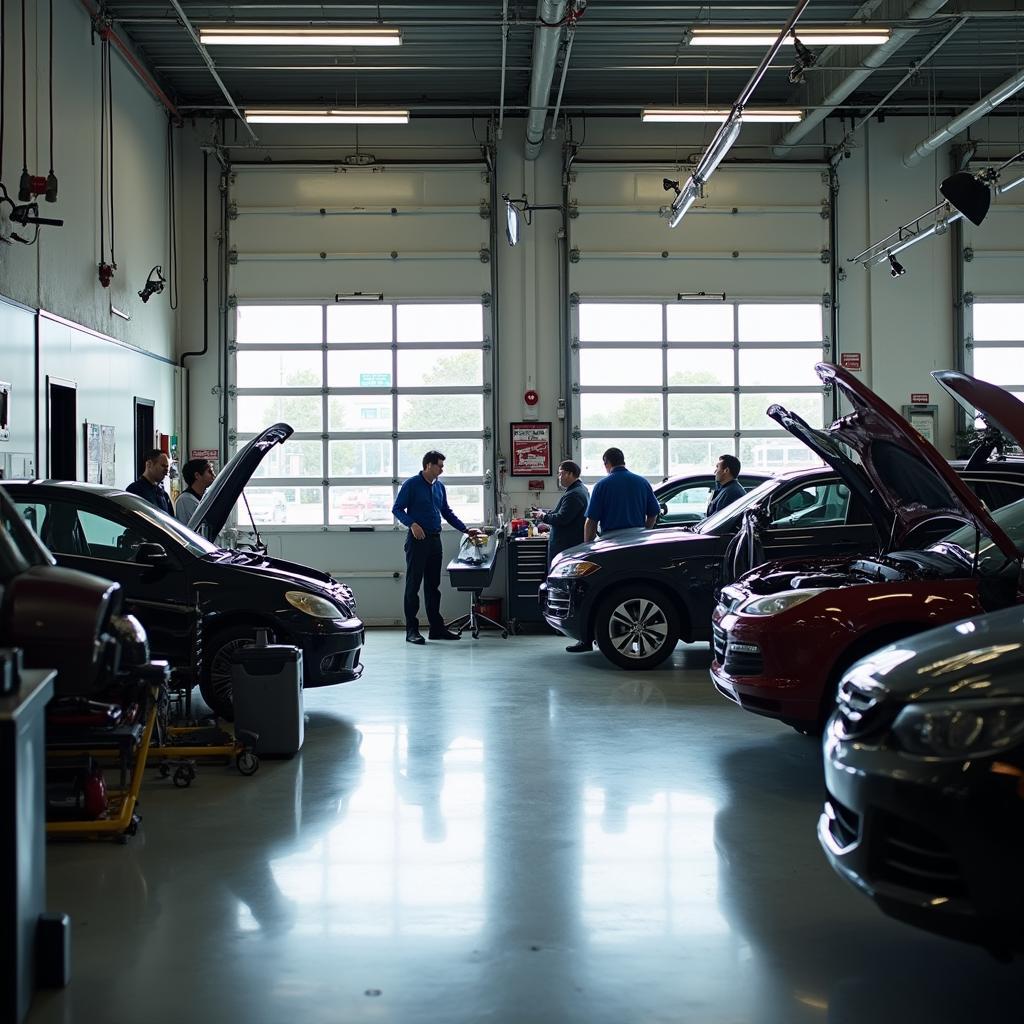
left=594, top=586, right=680, bottom=671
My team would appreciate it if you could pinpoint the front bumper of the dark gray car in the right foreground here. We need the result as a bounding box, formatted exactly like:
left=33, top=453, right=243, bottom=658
left=818, top=722, right=1024, bottom=952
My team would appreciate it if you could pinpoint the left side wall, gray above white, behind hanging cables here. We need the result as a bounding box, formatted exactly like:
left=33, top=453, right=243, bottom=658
left=0, top=0, right=179, bottom=475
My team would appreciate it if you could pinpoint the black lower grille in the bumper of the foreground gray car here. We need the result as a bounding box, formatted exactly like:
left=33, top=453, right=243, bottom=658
left=871, top=813, right=967, bottom=899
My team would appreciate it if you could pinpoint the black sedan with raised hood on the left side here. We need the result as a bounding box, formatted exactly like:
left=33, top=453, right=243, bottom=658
left=0, top=424, right=364, bottom=718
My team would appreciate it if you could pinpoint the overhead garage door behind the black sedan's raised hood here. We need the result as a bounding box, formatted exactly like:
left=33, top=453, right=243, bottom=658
left=229, top=165, right=493, bottom=529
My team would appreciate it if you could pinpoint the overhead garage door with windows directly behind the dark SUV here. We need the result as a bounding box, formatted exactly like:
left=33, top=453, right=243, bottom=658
left=569, top=164, right=831, bottom=479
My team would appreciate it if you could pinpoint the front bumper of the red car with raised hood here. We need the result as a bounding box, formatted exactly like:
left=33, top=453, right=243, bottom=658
left=711, top=607, right=824, bottom=727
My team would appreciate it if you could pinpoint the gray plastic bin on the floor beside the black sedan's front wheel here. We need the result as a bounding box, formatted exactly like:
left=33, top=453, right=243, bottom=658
left=231, top=644, right=303, bottom=757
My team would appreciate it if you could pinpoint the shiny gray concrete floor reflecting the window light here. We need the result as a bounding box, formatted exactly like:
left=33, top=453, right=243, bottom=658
left=29, top=631, right=1024, bottom=1024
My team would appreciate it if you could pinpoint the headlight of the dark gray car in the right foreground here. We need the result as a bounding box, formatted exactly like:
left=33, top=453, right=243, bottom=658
left=893, top=698, right=1024, bottom=761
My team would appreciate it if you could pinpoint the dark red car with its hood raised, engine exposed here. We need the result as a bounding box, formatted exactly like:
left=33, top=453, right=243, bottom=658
left=711, top=364, right=1024, bottom=732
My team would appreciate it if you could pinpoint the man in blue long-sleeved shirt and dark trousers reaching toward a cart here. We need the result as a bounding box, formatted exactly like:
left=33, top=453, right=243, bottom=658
left=391, top=452, right=479, bottom=644
